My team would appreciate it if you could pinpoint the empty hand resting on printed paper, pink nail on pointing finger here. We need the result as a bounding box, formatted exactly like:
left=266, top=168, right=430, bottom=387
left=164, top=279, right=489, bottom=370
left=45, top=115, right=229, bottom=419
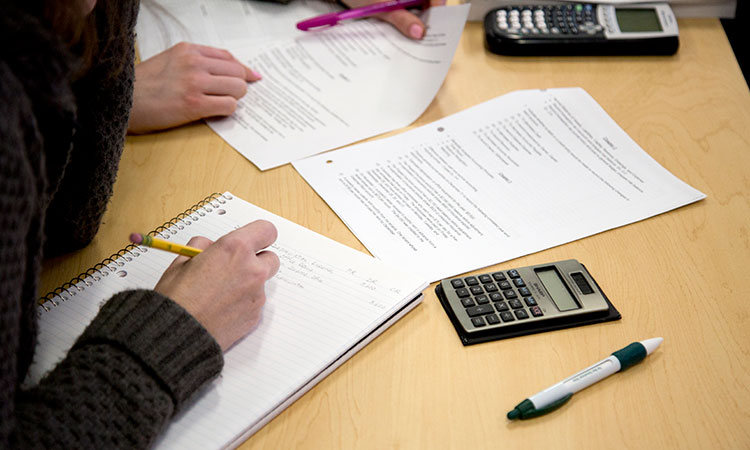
left=128, top=42, right=260, bottom=133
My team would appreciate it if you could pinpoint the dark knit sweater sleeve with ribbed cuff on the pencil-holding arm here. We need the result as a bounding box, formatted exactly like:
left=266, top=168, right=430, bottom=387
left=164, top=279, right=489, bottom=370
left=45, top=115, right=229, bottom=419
left=11, top=290, right=223, bottom=448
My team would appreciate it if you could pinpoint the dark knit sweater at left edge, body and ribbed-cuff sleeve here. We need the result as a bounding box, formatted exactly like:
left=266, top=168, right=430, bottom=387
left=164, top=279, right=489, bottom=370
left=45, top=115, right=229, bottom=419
left=0, top=1, right=223, bottom=448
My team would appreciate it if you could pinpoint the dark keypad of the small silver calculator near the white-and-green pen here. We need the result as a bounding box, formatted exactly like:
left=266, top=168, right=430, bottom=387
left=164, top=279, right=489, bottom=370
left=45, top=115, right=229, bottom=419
left=450, top=269, right=544, bottom=328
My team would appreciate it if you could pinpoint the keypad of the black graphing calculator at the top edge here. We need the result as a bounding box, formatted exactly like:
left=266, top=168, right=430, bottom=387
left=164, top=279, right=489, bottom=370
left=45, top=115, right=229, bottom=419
left=495, top=3, right=603, bottom=37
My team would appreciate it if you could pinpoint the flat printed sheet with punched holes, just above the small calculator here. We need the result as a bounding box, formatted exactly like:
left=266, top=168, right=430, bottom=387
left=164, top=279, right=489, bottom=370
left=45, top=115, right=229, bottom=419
left=294, top=88, right=705, bottom=280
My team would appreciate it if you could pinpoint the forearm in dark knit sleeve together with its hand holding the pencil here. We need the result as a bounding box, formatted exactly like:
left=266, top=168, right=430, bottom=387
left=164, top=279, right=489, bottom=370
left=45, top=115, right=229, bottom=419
left=2, top=222, right=279, bottom=448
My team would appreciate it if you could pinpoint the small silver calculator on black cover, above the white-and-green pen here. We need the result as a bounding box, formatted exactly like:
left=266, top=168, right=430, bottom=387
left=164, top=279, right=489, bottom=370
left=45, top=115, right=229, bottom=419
left=435, top=259, right=621, bottom=345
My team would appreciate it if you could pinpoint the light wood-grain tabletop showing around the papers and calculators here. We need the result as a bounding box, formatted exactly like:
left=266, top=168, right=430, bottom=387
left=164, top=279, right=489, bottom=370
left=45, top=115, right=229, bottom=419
left=42, top=19, right=750, bottom=449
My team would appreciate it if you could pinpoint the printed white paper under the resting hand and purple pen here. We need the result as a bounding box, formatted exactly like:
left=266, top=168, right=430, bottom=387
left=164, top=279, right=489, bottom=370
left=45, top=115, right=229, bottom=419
left=139, top=1, right=469, bottom=170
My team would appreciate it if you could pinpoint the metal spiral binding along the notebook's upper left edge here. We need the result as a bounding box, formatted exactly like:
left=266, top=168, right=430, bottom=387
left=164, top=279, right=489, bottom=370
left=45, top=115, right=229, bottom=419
left=37, top=192, right=232, bottom=311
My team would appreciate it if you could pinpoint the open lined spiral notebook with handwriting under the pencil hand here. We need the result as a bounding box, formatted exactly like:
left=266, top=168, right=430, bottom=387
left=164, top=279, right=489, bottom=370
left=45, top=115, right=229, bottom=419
left=25, top=192, right=427, bottom=449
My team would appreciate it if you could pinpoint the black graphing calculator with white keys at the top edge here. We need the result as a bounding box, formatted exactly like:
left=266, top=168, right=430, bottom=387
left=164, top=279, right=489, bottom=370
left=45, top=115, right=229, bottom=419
left=484, top=3, right=679, bottom=56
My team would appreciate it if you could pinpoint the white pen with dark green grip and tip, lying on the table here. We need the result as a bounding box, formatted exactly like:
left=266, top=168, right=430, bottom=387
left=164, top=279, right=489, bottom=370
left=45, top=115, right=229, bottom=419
left=508, top=337, right=664, bottom=420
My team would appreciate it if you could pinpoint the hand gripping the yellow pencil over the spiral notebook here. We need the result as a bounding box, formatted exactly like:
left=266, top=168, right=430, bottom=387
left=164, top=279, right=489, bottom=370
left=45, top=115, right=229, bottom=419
left=154, top=220, right=279, bottom=351
